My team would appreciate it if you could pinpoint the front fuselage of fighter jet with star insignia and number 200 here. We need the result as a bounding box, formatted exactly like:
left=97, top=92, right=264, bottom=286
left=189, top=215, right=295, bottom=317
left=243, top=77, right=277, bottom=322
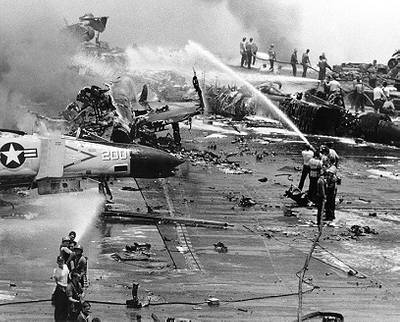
left=0, top=130, right=183, bottom=194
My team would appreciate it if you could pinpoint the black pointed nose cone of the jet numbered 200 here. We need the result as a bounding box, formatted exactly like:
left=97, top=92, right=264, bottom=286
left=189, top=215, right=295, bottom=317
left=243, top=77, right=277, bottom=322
left=131, top=146, right=184, bottom=178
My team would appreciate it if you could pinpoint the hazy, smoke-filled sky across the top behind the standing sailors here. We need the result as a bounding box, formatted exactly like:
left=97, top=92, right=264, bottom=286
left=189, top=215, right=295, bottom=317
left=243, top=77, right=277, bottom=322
left=0, top=0, right=400, bottom=64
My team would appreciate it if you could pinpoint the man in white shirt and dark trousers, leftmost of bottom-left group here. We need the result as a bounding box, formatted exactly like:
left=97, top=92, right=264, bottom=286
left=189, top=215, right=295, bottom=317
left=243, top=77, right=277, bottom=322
left=52, top=256, right=69, bottom=322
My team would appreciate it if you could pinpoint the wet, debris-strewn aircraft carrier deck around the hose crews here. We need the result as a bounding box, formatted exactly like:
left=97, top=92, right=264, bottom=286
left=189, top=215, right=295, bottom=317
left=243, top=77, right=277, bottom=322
left=0, top=120, right=400, bottom=321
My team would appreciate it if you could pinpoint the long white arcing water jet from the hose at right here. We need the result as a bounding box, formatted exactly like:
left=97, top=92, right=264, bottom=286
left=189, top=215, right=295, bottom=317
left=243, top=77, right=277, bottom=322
left=189, top=40, right=311, bottom=146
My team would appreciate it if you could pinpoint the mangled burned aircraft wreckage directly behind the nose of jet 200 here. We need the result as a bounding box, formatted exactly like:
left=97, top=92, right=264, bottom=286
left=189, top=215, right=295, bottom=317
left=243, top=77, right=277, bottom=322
left=62, top=74, right=204, bottom=147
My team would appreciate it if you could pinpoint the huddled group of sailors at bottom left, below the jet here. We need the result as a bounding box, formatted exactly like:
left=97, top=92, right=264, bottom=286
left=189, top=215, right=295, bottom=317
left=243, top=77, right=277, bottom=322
left=52, top=231, right=96, bottom=322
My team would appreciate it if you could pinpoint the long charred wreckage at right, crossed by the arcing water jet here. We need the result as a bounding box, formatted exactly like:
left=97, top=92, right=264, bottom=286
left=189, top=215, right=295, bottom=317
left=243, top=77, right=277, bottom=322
left=206, top=83, right=400, bottom=146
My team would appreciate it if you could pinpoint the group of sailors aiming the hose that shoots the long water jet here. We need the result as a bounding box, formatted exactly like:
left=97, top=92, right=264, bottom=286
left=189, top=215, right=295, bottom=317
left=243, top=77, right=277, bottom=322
left=298, top=143, right=340, bottom=227
